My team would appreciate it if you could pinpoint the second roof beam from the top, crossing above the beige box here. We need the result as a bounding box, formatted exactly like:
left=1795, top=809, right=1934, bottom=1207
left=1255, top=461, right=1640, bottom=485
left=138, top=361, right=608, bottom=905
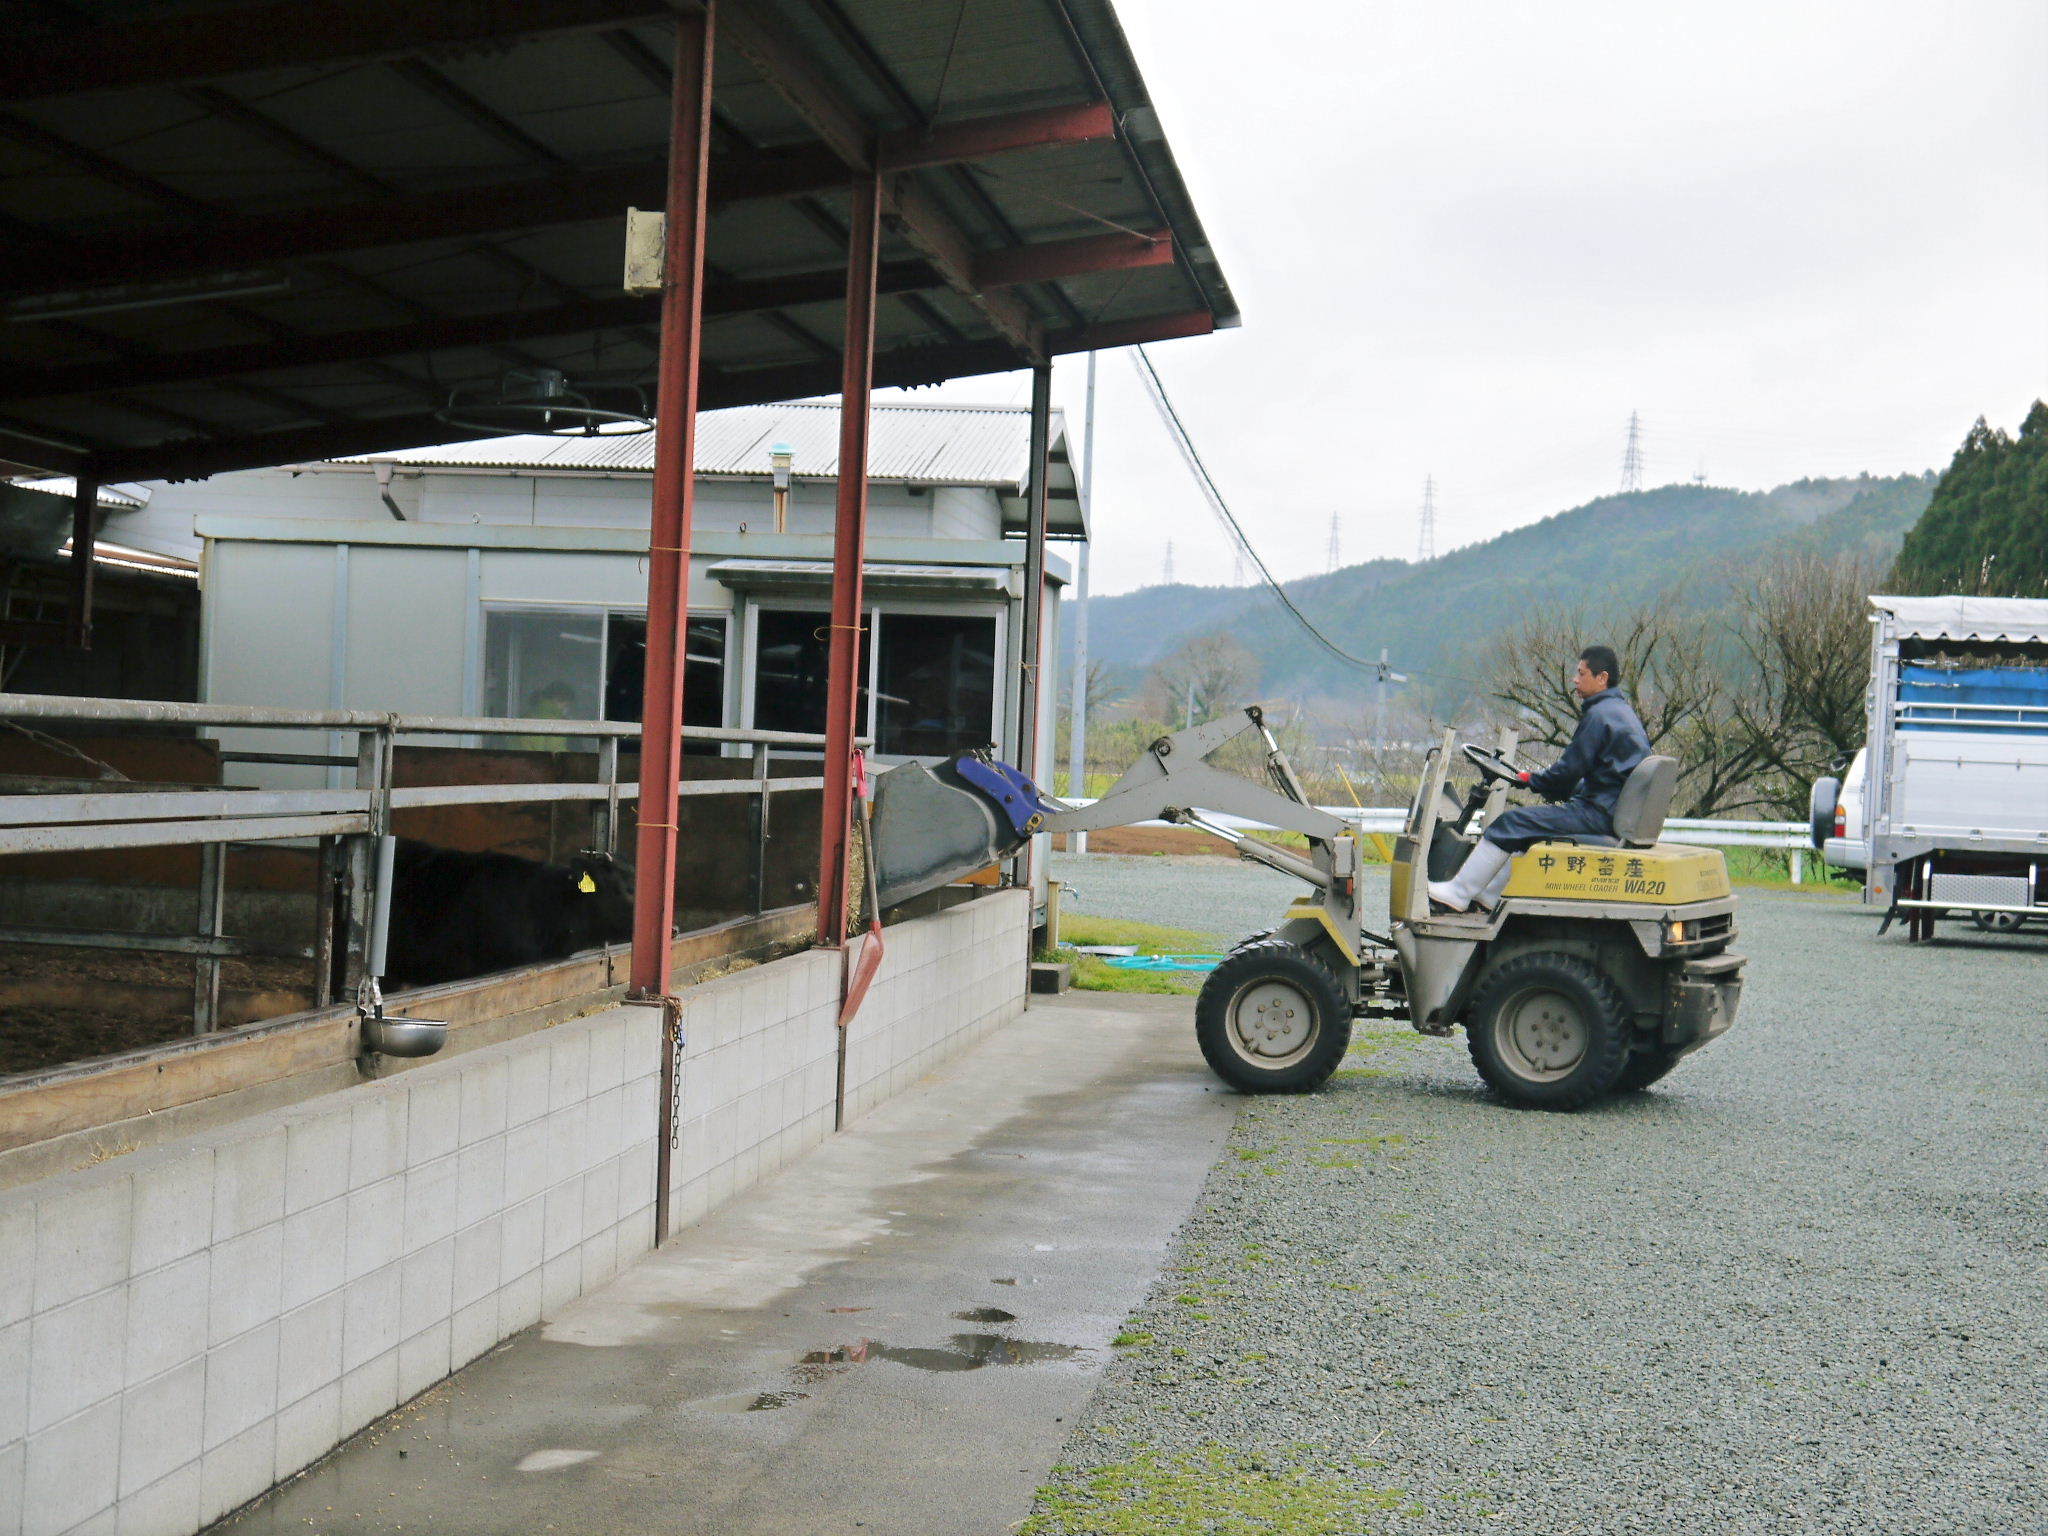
left=0, top=104, right=1114, bottom=303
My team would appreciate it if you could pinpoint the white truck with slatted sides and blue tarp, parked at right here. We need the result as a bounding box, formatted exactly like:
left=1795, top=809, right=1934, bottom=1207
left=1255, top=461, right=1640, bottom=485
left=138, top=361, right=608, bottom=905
left=1812, top=596, right=2048, bottom=938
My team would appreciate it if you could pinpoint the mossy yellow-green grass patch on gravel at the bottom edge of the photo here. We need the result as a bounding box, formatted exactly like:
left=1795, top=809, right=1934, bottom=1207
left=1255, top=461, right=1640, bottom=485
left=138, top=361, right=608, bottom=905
left=1022, top=1446, right=1425, bottom=1536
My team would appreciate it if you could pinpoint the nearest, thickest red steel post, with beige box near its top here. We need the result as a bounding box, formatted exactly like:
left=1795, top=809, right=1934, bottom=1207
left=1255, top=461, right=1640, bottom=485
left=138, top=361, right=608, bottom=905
left=633, top=0, right=717, bottom=999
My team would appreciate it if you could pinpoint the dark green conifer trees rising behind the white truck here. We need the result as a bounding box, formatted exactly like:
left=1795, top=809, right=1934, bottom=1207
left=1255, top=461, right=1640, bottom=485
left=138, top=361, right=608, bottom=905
left=1892, top=399, right=2048, bottom=598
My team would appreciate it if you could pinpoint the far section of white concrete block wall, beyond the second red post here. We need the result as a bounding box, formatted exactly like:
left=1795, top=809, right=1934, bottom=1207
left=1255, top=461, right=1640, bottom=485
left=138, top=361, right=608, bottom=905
left=846, top=891, right=1032, bottom=1124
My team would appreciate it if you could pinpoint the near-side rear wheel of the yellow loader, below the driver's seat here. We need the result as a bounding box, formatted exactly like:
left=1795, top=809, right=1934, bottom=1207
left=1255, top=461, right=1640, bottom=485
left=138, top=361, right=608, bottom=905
left=1464, top=950, right=1634, bottom=1110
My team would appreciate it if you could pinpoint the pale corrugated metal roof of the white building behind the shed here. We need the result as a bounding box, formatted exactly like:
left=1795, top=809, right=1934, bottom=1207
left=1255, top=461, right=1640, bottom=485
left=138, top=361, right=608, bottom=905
left=332, top=403, right=1065, bottom=492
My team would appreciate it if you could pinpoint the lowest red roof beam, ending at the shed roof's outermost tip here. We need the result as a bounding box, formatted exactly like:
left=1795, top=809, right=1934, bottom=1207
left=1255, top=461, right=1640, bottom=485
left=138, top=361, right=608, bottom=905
left=83, top=309, right=1217, bottom=485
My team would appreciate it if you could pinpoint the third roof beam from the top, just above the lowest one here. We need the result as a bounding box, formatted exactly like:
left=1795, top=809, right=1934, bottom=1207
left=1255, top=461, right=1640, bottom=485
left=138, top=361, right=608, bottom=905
left=0, top=233, right=1174, bottom=399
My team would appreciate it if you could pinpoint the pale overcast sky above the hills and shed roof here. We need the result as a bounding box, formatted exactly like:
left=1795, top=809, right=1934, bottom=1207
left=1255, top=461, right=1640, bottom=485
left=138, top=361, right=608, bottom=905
left=880, top=0, right=2048, bottom=592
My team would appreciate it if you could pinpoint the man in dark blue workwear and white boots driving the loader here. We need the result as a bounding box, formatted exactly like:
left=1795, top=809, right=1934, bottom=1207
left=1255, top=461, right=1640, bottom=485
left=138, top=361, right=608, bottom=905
left=1430, top=645, right=1651, bottom=911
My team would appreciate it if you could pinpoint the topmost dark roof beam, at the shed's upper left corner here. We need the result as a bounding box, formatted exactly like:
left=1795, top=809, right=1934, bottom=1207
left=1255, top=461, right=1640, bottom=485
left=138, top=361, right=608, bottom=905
left=0, top=0, right=674, bottom=100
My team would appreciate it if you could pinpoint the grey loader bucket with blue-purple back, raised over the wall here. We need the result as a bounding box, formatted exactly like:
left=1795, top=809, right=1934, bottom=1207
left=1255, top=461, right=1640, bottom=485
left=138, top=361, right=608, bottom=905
left=874, top=754, right=1065, bottom=907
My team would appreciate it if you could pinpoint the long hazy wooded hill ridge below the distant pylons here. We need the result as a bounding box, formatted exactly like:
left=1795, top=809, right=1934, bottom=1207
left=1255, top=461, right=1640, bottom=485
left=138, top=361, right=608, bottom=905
left=1087, top=473, right=1933, bottom=700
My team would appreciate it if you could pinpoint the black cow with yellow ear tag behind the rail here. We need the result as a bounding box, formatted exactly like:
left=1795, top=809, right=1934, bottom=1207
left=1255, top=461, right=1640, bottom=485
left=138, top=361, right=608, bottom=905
left=385, top=838, right=633, bottom=987
